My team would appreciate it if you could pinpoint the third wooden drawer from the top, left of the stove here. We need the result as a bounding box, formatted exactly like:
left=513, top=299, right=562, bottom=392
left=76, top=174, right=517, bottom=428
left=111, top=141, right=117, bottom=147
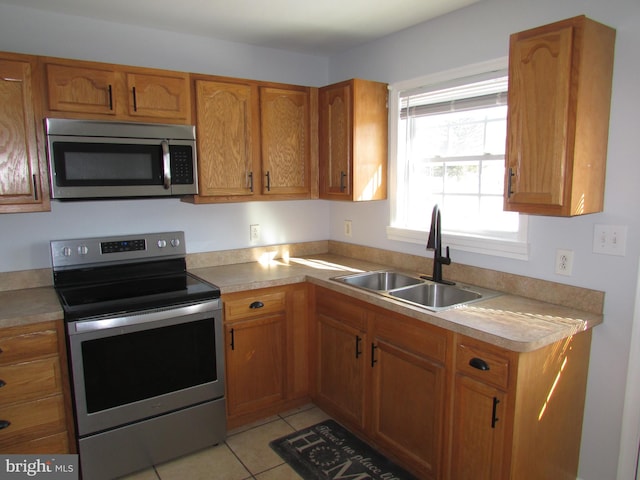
left=0, top=395, right=66, bottom=448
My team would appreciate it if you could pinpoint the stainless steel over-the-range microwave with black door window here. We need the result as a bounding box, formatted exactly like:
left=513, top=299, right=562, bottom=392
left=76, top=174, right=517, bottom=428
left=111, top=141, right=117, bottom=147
left=45, top=118, right=198, bottom=200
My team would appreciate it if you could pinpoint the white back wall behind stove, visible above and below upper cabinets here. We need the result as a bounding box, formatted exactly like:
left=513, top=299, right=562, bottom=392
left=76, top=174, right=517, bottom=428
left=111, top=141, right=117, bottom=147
left=0, top=3, right=329, bottom=272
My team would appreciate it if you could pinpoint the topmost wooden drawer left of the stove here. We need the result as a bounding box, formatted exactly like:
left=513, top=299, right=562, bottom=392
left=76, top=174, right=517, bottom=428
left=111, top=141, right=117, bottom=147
left=0, top=323, right=58, bottom=365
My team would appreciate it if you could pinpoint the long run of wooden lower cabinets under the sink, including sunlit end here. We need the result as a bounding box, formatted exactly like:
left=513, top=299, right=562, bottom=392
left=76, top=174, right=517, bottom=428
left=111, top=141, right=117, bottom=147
left=311, top=287, right=591, bottom=480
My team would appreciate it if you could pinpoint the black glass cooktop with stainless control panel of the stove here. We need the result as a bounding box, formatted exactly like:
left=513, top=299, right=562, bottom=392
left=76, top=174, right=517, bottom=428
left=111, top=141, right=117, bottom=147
left=51, top=232, right=220, bottom=321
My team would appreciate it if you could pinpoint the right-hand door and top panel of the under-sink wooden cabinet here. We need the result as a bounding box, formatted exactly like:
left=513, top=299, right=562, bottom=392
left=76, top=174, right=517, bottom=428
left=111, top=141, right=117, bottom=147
left=371, top=312, right=450, bottom=479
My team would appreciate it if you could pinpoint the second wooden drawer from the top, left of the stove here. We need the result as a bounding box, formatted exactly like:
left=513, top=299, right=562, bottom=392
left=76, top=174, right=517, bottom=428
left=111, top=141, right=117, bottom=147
left=0, top=355, right=62, bottom=407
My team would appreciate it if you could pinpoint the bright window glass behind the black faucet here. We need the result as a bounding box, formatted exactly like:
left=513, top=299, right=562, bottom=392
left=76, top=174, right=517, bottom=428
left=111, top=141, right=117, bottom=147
left=394, top=73, right=519, bottom=236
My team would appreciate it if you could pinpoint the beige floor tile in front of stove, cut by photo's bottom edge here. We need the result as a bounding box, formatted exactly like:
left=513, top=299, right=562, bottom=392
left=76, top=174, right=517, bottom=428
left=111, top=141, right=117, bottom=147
left=156, top=444, right=251, bottom=480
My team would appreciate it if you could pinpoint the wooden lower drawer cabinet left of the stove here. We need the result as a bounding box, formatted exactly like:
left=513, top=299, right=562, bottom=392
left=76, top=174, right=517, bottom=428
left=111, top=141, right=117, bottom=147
left=0, top=320, right=75, bottom=454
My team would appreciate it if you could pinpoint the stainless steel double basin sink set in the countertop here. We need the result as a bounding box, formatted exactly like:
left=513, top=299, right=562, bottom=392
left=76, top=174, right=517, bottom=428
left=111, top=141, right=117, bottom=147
left=332, top=270, right=500, bottom=311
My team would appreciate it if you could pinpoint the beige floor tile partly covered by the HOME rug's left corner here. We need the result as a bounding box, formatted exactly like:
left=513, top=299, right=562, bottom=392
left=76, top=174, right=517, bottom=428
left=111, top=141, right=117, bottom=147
left=225, top=419, right=294, bottom=474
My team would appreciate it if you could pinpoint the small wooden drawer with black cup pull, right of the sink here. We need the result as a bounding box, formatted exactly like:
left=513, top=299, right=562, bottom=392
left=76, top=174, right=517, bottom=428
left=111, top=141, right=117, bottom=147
left=456, top=341, right=512, bottom=389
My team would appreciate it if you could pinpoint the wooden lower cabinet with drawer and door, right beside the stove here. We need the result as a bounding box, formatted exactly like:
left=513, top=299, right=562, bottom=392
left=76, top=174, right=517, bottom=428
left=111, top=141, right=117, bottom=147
left=222, top=284, right=309, bottom=428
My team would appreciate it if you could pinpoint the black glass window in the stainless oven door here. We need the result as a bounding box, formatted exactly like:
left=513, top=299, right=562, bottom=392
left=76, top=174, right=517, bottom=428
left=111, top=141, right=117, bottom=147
left=82, top=318, right=217, bottom=413
